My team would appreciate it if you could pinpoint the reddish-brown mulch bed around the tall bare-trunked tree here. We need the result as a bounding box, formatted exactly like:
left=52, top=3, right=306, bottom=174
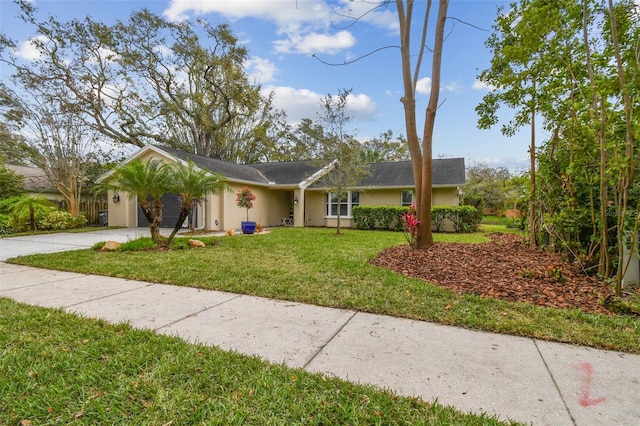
left=372, top=233, right=613, bottom=315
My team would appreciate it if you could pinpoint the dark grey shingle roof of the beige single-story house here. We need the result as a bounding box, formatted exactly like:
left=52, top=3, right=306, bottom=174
left=100, top=145, right=465, bottom=189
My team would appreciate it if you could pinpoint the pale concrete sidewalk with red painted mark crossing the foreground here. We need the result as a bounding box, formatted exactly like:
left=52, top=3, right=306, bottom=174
left=0, top=262, right=640, bottom=426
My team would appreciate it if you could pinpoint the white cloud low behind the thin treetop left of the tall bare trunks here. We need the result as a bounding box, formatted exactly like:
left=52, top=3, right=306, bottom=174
left=264, top=86, right=376, bottom=123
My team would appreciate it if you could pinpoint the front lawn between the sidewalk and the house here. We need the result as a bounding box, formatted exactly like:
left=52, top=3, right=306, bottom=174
left=13, top=228, right=640, bottom=353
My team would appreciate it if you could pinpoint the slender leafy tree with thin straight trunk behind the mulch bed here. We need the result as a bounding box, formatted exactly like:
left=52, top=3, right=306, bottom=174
left=476, top=0, right=576, bottom=247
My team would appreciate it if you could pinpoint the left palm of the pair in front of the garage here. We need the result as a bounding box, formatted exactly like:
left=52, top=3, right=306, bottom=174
left=106, top=158, right=172, bottom=247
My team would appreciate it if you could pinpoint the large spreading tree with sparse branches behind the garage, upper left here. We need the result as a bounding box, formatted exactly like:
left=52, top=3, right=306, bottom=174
left=0, top=1, right=282, bottom=161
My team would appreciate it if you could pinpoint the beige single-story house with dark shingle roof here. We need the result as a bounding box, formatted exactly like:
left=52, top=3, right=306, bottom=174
left=103, top=145, right=465, bottom=231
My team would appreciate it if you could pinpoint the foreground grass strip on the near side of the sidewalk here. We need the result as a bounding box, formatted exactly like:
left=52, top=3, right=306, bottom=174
left=0, top=298, right=516, bottom=425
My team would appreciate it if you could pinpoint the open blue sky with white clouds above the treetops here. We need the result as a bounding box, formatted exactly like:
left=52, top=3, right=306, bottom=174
left=0, top=0, right=545, bottom=171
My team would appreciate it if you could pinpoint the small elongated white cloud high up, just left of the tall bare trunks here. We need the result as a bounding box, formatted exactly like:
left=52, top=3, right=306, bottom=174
left=273, top=30, right=356, bottom=54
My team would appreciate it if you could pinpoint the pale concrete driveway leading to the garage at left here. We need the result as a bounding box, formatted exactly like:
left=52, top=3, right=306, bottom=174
left=0, top=228, right=171, bottom=262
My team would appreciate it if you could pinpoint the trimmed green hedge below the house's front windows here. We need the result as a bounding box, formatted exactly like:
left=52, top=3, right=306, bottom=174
left=352, top=206, right=482, bottom=233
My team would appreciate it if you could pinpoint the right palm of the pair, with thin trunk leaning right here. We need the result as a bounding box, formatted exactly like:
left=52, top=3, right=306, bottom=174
left=166, top=160, right=227, bottom=245
